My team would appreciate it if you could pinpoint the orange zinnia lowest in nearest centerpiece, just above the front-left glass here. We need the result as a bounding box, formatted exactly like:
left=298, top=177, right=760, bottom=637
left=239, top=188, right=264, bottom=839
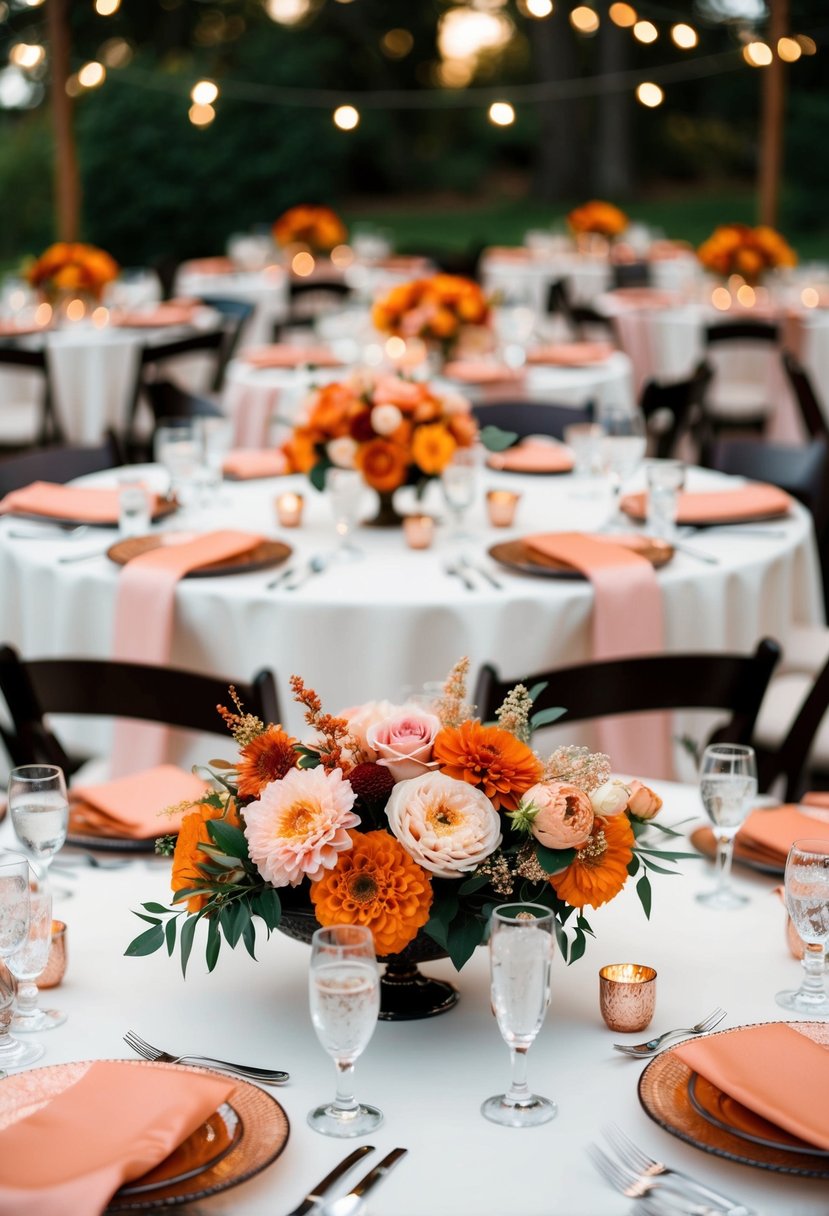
left=311, top=832, right=432, bottom=957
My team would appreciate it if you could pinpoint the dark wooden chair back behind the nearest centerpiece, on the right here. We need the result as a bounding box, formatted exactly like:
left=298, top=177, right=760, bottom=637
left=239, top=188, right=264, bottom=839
left=473, top=638, right=780, bottom=773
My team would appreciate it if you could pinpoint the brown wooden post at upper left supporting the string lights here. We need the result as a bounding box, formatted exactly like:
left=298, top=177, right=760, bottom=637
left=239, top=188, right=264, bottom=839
left=46, top=0, right=80, bottom=241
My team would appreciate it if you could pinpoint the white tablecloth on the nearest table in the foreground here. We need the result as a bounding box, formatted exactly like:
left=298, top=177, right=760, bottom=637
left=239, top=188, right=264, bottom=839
left=0, top=786, right=827, bottom=1216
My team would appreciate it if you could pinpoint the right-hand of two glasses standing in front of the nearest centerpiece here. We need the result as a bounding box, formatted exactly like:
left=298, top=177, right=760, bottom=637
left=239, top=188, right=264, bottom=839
left=480, top=903, right=558, bottom=1127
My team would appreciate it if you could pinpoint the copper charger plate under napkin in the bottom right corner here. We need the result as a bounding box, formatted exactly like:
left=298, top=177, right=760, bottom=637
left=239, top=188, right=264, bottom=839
left=639, top=1021, right=829, bottom=1178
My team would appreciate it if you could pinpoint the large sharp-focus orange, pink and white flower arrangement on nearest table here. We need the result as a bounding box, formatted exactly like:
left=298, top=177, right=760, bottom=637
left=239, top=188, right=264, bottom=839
left=126, top=659, right=692, bottom=1011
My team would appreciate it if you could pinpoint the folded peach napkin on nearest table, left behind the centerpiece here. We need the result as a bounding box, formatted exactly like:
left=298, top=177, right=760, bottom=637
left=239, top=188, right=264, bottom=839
left=69, top=764, right=208, bottom=840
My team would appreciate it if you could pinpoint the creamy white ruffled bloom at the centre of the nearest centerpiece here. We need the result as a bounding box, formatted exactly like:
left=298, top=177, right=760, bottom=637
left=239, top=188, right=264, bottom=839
left=385, top=772, right=501, bottom=878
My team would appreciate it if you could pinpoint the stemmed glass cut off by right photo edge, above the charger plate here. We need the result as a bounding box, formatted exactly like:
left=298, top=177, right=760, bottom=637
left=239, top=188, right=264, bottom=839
left=776, top=839, right=829, bottom=1018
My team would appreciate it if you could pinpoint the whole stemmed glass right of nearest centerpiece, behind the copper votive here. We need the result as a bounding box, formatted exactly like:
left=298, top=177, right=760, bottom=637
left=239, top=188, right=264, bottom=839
left=697, top=743, right=757, bottom=908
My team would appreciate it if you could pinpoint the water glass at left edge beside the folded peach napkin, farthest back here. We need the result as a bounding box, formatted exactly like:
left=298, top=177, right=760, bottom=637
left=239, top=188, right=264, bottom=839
left=9, top=764, right=69, bottom=884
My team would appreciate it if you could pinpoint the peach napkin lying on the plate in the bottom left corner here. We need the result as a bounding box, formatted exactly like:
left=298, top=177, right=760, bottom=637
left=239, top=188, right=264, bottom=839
left=0, top=1060, right=238, bottom=1216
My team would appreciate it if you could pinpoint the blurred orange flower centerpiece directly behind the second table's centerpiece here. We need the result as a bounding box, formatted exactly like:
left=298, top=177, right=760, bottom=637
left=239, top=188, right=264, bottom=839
left=372, top=275, right=490, bottom=356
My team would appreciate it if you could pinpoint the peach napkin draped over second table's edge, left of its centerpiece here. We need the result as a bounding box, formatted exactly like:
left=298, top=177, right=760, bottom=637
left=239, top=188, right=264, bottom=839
left=112, top=530, right=261, bottom=777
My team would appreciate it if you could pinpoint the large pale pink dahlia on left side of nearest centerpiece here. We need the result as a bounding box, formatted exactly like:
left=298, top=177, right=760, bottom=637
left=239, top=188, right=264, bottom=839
left=244, top=767, right=360, bottom=886
